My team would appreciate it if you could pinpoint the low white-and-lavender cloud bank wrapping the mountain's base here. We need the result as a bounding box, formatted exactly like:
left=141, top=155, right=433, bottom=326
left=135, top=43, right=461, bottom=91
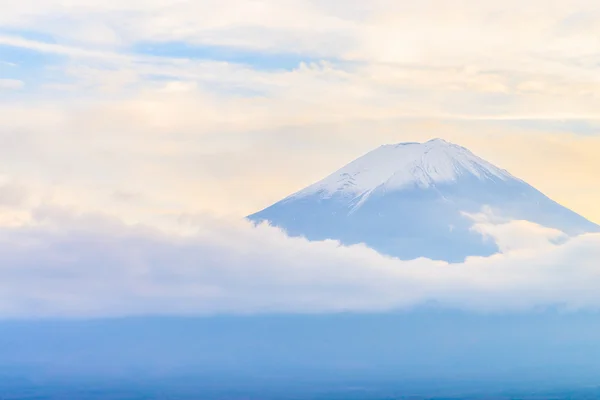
left=0, top=209, right=600, bottom=318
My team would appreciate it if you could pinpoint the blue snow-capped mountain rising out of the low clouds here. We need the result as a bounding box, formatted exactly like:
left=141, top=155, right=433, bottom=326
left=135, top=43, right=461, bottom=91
left=248, top=139, right=600, bottom=262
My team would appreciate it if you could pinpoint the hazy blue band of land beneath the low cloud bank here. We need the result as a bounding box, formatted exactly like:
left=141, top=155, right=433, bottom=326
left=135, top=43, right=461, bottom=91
left=0, top=310, right=600, bottom=399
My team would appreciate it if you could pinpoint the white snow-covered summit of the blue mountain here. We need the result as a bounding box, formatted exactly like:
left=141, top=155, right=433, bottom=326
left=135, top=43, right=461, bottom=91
left=291, top=139, right=515, bottom=202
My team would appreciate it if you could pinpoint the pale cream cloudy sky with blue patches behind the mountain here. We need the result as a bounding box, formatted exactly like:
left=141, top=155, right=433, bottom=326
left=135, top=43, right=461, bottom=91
left=0, top=0, right=600, bottom=315
